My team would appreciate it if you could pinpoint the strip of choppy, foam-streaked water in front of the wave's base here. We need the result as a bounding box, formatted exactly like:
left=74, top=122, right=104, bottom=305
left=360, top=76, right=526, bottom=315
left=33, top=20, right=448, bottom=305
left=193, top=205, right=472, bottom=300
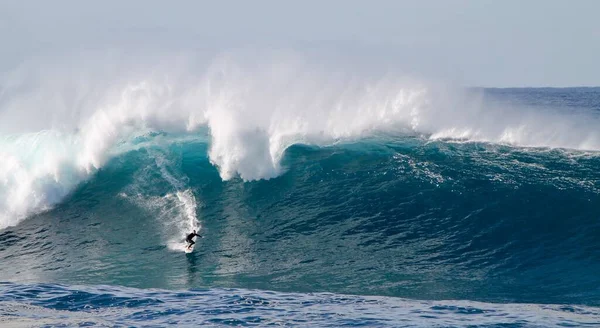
left=0, top=284, right=600, bottom=327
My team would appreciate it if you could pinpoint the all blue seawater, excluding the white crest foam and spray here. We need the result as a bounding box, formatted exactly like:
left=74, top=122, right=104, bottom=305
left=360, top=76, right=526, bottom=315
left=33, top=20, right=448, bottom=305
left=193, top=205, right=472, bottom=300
left=0, top=88, right=600, bottom=327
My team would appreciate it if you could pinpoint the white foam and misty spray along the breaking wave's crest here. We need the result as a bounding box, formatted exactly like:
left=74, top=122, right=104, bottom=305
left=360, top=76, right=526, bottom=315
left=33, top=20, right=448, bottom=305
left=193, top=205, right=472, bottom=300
left=0, top=51, right=600, bottom=229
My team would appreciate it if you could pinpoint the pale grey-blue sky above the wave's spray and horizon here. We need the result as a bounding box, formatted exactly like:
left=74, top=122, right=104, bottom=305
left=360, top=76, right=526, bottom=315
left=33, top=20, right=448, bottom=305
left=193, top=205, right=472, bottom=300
left=0, top=0, right=600, bottom=87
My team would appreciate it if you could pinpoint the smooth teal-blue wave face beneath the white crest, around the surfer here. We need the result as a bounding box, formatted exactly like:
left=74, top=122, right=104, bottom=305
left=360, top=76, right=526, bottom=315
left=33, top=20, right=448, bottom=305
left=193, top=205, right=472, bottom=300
left=0, top=130, right=600, bottom=304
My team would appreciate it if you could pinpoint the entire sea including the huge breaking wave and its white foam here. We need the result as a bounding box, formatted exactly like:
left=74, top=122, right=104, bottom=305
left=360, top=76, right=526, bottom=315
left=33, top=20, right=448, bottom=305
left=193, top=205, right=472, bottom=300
left=0, top=58, right=600, bottom=327
